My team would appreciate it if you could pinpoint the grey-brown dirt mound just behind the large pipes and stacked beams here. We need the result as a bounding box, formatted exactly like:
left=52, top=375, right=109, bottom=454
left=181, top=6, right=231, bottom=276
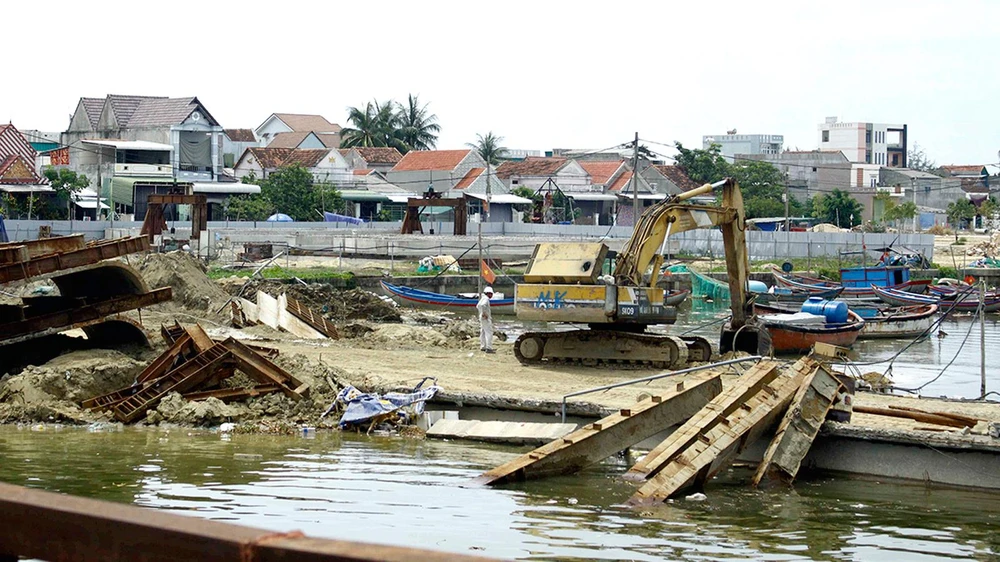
left=135, top=251, right=229, bottom=311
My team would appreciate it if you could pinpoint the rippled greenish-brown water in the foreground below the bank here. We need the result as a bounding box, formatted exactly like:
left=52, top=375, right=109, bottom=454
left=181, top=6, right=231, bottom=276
left=0, top=427, right=1000, bottom=560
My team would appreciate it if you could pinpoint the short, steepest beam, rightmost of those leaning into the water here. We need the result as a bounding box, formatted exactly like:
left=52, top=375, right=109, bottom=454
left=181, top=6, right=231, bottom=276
left=752, top=360, right=841, bottom=487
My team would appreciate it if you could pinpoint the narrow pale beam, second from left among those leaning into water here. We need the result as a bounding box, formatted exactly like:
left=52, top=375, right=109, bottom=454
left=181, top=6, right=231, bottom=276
left=624, top=360, right=781, bottom=482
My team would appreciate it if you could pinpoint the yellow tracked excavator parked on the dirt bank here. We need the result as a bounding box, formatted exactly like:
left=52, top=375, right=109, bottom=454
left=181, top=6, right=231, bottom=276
left=514, top=178, right=766, bottom=369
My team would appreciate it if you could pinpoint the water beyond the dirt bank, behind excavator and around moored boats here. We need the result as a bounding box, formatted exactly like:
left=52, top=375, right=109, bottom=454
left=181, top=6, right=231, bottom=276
left=498, top=299, right=1000, bottom=400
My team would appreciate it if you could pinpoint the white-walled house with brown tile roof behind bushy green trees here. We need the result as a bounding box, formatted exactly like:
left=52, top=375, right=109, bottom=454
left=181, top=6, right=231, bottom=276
left=234, top=147, right=353, bottom=185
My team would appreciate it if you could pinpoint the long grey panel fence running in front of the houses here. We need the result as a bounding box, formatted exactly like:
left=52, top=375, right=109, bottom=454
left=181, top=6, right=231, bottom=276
left=7, top=220, right=934, bottom=260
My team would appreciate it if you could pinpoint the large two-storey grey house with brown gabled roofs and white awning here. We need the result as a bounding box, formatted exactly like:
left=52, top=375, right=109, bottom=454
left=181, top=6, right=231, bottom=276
left=62, top=94, right=227, bottom=216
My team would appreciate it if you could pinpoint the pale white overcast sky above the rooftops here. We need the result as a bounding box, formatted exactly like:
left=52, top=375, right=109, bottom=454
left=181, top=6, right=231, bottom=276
left=0, top=0, right=1000, bottom=167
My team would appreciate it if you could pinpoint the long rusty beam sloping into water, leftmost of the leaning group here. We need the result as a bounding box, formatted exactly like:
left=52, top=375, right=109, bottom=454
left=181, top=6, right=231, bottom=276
left=478, top=373, right=722, bottom=485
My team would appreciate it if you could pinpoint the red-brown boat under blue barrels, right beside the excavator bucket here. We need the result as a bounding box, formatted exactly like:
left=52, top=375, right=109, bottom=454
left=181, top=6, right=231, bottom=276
left=754, top=304, right=865, bottom=354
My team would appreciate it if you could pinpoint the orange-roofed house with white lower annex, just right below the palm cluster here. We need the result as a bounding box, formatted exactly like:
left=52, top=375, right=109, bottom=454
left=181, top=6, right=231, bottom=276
left=386, top=149, right=531, bottom=222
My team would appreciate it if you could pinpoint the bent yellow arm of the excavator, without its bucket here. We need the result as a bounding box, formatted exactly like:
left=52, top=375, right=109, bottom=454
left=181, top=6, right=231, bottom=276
left=614, top=178, right=750, bottom=329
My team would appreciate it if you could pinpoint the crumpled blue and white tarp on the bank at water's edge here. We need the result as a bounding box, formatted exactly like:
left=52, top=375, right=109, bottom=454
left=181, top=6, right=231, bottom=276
left=324, top=377, right=441, bottom=429
